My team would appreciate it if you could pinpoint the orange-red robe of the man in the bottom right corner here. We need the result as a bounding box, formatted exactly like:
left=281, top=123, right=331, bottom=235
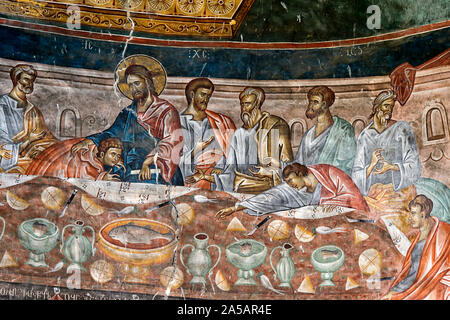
left=392, top=217, right=450, bottom=300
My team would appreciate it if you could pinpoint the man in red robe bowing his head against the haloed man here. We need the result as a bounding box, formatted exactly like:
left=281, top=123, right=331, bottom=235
left=26, top=138, right=125, bottom=181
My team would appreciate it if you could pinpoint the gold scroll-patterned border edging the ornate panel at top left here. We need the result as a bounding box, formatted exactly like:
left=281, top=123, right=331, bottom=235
left=0, top=0, right=254, bottom=38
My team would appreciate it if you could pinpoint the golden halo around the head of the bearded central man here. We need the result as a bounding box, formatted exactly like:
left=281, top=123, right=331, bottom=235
left=114, top=54, right=167, bottom=100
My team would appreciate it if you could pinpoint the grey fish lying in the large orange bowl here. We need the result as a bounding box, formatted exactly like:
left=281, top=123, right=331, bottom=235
left=108, top=222, right=173, bottom=247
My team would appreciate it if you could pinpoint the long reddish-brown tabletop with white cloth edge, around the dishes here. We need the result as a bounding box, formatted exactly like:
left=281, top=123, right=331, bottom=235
left=0, top=174, right=403, bottom=300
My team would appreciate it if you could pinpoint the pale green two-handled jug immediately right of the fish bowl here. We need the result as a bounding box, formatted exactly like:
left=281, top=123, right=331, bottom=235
left=180, top=233, right=221, bottom=284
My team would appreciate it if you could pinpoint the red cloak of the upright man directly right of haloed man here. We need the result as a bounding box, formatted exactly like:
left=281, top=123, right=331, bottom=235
left=192, top=110, right=236, bottom=190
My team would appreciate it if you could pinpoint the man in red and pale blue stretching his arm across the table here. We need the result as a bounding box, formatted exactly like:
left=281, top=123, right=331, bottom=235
left=216, top=162, right=369, bottom=219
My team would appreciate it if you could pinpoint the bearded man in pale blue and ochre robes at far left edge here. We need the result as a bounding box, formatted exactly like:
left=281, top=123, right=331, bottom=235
left=0, top=64, right=57, bottom=174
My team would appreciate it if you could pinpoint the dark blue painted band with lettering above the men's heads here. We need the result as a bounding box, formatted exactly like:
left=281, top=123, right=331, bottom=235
left=0, top=26, right=449, bottom=80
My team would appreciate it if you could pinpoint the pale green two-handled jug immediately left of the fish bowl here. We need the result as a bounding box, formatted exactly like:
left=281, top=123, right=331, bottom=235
left=60, top=220, right=95, bottom=271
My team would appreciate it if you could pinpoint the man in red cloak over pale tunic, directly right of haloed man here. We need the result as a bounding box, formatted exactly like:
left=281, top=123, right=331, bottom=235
left=180, top=78, right=236, bottom=189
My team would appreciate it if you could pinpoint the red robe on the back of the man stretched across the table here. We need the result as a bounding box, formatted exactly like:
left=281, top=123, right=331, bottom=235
left=308, top=164, right=369, bottom=212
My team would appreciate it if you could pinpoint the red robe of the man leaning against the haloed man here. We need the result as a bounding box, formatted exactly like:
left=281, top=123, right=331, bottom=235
left=26, top=138, right=106, bottom=180
